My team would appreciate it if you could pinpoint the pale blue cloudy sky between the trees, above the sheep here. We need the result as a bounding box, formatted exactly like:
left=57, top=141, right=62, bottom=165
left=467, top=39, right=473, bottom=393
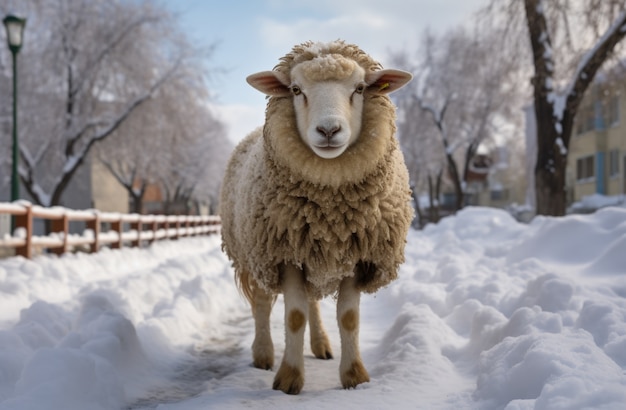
left=162, top=0, right=486, bottom=141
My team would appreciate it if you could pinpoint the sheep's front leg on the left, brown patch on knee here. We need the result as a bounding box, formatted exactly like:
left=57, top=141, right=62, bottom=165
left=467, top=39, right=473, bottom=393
left=274, top=265, right=308, bottom=394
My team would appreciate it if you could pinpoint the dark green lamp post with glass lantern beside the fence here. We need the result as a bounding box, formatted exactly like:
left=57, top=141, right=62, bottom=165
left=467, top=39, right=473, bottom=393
left=2, top=14, right=26, bottom=232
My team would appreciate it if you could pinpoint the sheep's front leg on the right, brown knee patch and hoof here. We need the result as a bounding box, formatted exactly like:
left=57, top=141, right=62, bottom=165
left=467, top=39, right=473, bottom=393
left=337, top=277, right=370, bottom=389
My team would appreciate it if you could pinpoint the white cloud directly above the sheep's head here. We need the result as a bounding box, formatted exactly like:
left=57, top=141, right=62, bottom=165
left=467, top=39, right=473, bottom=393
left=258, top=0, right=485, bottom=66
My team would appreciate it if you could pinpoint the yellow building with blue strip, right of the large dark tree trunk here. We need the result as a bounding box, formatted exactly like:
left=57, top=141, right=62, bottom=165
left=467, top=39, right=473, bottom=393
left=567, top=79, right=626, bottom=202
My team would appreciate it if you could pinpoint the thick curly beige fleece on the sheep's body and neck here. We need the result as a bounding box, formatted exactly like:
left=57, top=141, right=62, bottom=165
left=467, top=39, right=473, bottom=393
left=220, top=43, right=413, bottom=298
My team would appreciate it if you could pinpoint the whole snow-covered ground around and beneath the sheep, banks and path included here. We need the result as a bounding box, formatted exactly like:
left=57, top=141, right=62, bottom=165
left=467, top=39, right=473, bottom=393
left=0, top=207, right=626, bottom=410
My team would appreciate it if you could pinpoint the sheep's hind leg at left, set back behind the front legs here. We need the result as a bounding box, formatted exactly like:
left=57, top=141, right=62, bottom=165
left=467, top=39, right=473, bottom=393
left=252, top=287, right=274, bottom=370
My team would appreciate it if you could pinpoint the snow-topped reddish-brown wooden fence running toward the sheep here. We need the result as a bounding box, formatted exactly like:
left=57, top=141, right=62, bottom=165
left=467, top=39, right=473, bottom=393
left=0, top=201, right=220, bottom=258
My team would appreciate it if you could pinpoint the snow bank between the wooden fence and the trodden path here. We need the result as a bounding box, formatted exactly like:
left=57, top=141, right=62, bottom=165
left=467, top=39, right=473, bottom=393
left=0, top=236, right=243, bottom=410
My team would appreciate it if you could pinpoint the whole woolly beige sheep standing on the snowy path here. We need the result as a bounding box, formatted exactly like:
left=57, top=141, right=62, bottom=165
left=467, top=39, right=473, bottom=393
left=220, top=40, right=413, bottom=394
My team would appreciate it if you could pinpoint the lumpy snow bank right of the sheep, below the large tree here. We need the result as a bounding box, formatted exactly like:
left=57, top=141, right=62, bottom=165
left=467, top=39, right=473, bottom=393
left=376, top=208, right=626, bottom=409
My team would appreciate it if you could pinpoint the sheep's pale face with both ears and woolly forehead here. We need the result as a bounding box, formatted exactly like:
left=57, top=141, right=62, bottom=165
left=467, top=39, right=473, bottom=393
left=247, top=44, right=411, bottom=159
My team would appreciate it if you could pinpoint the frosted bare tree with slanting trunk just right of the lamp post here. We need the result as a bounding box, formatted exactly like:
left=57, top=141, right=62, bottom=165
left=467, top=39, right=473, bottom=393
left=0, top=0, right=197, bottom=206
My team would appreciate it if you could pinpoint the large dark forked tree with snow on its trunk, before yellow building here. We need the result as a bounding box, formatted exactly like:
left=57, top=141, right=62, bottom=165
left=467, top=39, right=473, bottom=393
left=486, top=0, right=626, bottom=216
